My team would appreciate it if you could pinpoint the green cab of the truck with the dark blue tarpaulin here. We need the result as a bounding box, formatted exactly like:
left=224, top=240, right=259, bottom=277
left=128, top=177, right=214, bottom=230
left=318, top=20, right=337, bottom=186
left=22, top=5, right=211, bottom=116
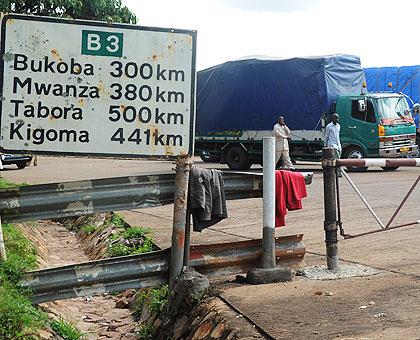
left=333, top=93, right=418, bottom=169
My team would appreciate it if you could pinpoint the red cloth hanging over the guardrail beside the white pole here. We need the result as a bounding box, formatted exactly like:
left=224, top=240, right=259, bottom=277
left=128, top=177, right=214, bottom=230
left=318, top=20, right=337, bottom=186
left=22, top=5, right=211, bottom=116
left=275, top=170, right=307, bottom=228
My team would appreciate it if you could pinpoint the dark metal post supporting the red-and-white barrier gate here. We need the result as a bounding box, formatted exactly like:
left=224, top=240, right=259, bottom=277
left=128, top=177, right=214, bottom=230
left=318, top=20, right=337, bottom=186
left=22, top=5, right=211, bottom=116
left=322, top=148, right=338, bottom=272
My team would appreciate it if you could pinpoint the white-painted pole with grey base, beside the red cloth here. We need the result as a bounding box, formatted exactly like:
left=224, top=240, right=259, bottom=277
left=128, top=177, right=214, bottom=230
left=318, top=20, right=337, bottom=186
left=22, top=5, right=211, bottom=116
left=262, top=137, right=276, bottom=268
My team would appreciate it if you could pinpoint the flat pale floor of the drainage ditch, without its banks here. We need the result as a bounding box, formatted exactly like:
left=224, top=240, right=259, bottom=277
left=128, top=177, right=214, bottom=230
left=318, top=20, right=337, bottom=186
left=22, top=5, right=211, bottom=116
left=22, top=221, right=138, bottom=339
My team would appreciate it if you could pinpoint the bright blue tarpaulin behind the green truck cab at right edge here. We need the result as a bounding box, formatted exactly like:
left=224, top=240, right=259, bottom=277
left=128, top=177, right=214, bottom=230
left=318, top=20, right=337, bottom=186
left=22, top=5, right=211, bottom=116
left=365, top=65, right=420, bottom=106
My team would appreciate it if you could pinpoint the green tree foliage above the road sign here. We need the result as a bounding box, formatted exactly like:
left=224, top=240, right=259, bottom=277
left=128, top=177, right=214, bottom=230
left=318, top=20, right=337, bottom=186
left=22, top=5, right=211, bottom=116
left=0, top=0, right=137, bottom=24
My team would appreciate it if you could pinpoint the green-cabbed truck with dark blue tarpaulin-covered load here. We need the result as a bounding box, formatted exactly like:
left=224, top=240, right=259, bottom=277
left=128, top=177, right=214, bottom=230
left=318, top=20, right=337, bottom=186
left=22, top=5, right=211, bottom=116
left=195, top=54, right=418, bottom=170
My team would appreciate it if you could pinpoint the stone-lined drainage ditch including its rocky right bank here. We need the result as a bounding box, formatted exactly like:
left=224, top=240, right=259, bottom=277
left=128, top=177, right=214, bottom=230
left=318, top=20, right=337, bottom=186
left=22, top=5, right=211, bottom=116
left=21, top=214, right=263, bottom=339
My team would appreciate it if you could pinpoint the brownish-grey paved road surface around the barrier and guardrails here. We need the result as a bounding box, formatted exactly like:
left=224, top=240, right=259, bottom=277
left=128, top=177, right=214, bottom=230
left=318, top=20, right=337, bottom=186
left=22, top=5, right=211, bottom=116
left=2, top=157, right=420, bottom=339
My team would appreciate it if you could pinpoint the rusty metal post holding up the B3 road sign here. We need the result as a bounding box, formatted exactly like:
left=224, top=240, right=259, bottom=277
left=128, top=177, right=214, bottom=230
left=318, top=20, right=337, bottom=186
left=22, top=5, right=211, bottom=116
left=169, top=156, right=191, bottom=287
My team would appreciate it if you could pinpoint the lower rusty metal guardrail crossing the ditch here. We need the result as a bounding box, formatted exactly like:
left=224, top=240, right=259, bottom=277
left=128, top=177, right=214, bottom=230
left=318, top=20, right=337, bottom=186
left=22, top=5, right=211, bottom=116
left=21, top=234, right=305, bottom=304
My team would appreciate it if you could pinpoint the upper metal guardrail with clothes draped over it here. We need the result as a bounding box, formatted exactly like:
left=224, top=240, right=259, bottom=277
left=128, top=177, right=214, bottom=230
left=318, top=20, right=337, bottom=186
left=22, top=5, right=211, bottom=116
left=0, top=171, right=312, bottom=223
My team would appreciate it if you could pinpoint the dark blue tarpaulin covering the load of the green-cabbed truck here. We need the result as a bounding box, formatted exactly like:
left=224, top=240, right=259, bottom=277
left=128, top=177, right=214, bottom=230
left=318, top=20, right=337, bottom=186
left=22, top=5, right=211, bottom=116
left=196, top=55, right=365, bottom=135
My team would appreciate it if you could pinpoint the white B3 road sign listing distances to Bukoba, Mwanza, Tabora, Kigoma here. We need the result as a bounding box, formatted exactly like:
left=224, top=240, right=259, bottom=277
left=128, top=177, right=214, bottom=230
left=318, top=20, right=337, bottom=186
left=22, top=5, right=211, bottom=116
left=0, top=15, right=196, bottom=157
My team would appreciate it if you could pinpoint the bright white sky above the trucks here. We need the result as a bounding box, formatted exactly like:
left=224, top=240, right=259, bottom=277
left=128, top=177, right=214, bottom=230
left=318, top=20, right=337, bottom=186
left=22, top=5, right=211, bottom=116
left=123, top=0, right=420, bottom=70
